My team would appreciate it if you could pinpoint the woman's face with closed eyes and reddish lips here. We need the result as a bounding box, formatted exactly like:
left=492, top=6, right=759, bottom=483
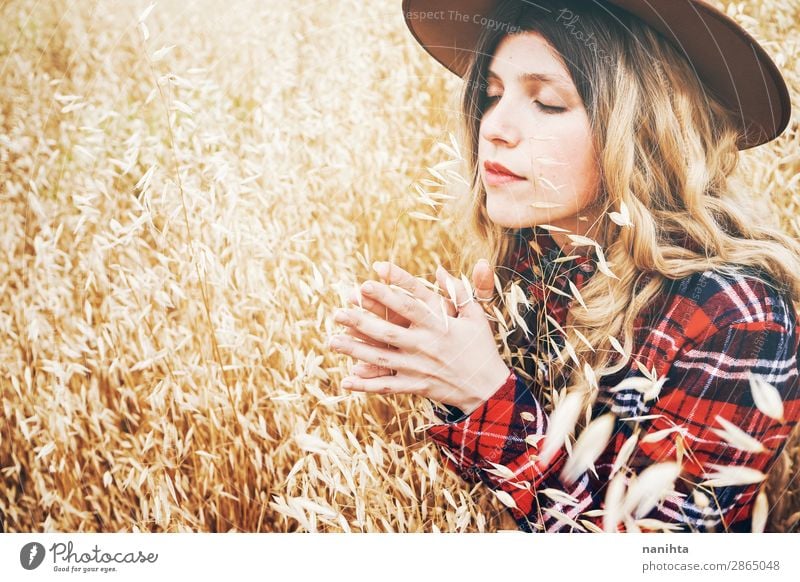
left=478, top=32, right=599, bottom=246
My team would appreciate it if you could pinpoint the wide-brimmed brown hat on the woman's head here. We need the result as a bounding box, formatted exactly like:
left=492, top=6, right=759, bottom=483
left=403, top=0, right=792, bottom=150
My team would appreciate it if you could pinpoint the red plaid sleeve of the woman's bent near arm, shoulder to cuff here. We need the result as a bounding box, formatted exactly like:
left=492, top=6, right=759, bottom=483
left=428, top=321, right=800, bottom=532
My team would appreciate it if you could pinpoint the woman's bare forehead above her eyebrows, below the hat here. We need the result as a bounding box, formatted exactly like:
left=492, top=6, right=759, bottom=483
left=488, top=32, right=573, bottom=87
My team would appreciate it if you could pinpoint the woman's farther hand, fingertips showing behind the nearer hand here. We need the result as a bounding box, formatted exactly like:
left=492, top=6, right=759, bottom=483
left=346, top=259, right=494, bottom=378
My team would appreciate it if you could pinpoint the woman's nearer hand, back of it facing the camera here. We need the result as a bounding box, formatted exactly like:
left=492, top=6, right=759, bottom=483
left=331, top=264, right=509, bottom=413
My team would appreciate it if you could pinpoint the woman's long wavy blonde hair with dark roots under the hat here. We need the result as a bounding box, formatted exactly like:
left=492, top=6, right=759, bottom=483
left=444, top=1, right=800, bottom=531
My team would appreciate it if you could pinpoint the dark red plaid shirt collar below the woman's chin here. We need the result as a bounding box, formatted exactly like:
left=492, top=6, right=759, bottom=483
left=514, top=227, right=597, bottom=295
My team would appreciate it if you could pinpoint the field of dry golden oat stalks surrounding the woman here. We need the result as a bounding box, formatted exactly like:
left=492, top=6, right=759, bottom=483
left=0, top=0, right=800, bottom=532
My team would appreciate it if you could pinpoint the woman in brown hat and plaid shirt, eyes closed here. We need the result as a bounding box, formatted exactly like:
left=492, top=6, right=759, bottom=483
left=324, top=0, right=800, bottom=532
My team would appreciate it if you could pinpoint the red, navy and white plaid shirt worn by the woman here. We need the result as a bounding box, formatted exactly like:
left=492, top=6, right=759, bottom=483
left=426, top=229, right=800, bottom=532
